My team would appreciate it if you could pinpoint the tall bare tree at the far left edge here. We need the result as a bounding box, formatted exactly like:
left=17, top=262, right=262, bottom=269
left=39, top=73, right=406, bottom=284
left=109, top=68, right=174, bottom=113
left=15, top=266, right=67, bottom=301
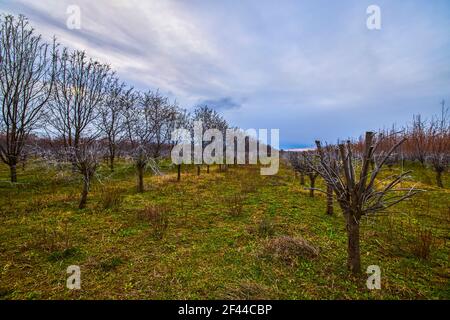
left=0, top=15, right=56, bottom=182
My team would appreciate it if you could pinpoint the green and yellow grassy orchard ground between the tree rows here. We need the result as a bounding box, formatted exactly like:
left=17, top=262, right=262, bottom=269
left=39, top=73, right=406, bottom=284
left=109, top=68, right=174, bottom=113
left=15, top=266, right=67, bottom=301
left=0, top=162, right=450, bottom=299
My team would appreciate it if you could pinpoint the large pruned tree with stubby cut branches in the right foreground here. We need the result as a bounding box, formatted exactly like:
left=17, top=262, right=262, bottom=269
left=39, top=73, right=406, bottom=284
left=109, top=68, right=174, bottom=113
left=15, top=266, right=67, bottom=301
left=309, top=132, right=418, bottom=273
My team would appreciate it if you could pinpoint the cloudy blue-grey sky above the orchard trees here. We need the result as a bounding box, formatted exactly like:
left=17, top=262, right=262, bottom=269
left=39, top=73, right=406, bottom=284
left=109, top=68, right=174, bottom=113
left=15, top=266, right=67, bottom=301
left=0, top=0, right=450, bottom=149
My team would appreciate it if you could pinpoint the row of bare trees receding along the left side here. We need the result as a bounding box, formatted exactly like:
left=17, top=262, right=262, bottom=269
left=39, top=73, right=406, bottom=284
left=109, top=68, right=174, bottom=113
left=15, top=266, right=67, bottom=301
left=0, top=15, right=228, bottom=208
